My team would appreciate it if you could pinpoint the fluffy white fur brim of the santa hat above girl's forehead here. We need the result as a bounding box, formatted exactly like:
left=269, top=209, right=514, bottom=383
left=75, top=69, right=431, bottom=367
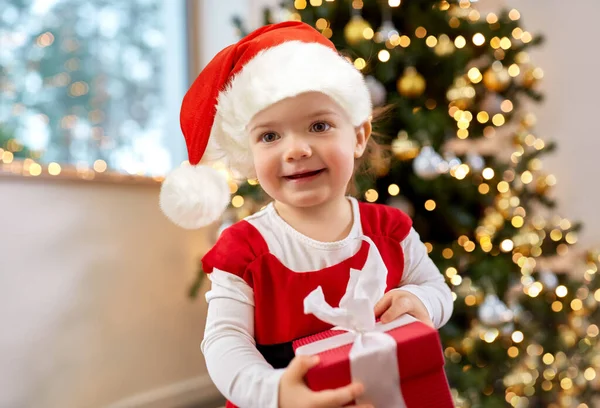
left=203, top=41, right=372, bottom=178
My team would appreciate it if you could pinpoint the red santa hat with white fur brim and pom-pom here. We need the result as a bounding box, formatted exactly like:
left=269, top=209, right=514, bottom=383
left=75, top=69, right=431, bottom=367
left=160, top=21, right=372, bottom=229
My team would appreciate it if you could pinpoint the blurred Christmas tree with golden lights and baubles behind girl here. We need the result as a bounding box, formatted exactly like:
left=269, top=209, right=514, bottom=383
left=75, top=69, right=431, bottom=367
left=195, top=0, right=600, bottom=408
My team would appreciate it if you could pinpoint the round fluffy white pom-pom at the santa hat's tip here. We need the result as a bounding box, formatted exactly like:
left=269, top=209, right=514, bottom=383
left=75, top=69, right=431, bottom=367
left=159, top=163, right=230, bottom=229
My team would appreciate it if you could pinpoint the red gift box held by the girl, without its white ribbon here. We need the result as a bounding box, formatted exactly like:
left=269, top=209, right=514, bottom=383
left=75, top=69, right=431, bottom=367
left=293, top=321, right=454, bottom=408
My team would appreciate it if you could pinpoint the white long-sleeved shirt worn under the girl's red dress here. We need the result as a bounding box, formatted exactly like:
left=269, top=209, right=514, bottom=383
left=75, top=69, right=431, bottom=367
left=201, top=197, right=453, bottom=408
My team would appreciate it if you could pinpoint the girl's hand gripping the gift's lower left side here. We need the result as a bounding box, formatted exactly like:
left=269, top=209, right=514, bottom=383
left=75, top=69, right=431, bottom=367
left=279, top=356, right=373, bottom=408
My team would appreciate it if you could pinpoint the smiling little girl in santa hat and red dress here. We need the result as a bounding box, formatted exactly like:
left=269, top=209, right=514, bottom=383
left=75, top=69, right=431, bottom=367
left=160, top=22, right=453, bottom=408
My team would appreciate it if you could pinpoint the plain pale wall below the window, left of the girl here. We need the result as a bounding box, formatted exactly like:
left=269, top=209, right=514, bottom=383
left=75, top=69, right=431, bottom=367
left=0, top=178, right=220, bottom=408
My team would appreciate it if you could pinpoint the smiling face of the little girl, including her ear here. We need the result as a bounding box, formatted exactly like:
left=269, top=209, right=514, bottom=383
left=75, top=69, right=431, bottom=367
left=248, top=92, right=371, bottom=208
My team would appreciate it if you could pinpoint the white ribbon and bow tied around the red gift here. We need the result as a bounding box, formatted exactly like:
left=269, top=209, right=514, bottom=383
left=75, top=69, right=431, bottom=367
left=296, top=235, right=416, bottom=408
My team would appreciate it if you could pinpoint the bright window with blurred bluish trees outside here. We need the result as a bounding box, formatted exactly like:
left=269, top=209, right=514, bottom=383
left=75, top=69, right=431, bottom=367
left=0, top=0, right=187, bottom=175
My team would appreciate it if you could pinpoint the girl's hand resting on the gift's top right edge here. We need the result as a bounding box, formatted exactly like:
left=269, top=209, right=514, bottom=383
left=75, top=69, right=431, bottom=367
left=375, top=290, right=434, bottom=327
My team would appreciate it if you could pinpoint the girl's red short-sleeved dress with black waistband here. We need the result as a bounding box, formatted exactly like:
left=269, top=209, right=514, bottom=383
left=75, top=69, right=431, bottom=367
left=202, top=203, right=412, bottom=408
